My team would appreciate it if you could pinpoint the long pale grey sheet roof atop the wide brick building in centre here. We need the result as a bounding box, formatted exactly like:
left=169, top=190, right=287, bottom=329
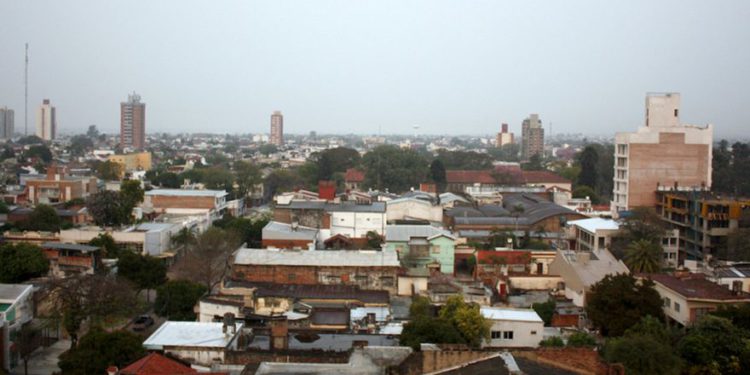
left=234, top=249, right=400, bottom=267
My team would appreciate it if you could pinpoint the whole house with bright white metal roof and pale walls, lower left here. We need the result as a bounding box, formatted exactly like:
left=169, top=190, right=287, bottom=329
left=143, top=319, right=248, bottom=366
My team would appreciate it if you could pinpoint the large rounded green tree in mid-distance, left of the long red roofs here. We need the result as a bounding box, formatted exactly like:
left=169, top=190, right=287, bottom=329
left=362, top=145, right=427, bottom=192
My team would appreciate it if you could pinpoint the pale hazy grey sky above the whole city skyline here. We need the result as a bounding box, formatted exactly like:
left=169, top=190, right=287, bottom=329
left=0, top=0, right=750, bottom=138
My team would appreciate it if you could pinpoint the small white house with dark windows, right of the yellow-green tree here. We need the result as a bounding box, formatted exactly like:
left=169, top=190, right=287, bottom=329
left=479, top=307, right=544, bottom=348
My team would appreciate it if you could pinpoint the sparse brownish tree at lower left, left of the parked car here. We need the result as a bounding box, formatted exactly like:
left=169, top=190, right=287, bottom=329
left=47, top=274, right=136, bottom=348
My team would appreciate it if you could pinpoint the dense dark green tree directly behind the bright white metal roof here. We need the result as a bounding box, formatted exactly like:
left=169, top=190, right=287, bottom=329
left=154, top=280, right=207, bottom=321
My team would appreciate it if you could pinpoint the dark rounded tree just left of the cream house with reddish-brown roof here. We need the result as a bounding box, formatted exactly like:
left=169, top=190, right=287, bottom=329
left=586, top=274, right=664, bottom=336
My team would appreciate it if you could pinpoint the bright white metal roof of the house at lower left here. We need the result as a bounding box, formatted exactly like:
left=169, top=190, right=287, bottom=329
left=143, top=321, right=242, bottom=350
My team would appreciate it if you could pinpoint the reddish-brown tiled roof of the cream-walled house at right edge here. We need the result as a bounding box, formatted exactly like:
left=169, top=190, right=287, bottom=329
left=640, top=273, right=750, bottom=301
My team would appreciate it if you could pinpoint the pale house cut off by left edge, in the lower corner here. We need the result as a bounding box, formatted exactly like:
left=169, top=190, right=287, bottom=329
left=0, top=284, right=34, bottom=371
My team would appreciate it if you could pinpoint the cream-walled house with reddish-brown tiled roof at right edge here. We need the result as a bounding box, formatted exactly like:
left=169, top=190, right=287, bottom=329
left=641, top=273, right=750, bottom=326
